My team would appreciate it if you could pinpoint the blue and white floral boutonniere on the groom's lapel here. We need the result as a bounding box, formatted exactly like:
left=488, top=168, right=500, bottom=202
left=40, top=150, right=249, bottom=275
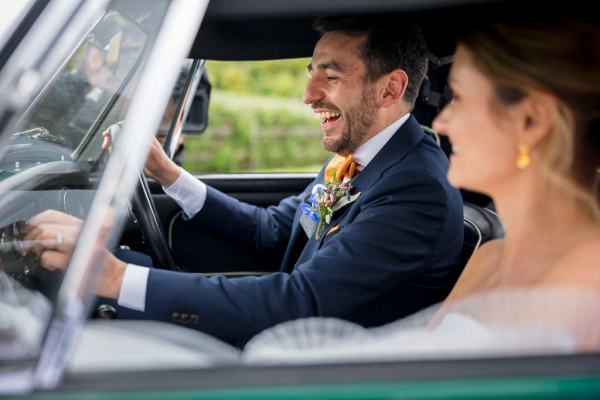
left=300, top=182, right=360, bottom=240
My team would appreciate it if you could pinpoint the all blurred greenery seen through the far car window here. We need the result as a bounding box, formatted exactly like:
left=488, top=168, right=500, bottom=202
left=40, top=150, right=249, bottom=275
left=183, top=59, right=329, bottom=173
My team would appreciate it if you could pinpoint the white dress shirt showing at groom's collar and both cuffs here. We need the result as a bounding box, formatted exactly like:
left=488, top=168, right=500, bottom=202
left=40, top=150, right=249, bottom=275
left=118, top=114, right=410, bottom=311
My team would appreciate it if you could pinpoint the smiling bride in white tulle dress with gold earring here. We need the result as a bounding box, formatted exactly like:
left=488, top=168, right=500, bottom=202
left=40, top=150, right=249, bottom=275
left=246, top=19, right=600, bottom=361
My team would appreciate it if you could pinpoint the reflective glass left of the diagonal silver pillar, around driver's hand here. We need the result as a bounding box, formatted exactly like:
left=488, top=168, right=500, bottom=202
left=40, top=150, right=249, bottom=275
left=0, top=1, right=167, bottom=361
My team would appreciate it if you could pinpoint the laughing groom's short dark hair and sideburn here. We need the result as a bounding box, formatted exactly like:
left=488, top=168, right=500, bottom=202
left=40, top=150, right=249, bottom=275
left=313, top=16, right=427, bottom=110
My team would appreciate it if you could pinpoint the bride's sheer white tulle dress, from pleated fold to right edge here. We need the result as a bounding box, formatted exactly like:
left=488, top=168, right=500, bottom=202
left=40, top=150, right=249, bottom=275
left=243, top=288, right=600, bottom=363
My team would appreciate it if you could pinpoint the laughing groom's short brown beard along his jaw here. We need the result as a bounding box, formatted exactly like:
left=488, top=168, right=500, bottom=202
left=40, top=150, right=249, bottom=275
left=321, top=86, right=377, bottom=155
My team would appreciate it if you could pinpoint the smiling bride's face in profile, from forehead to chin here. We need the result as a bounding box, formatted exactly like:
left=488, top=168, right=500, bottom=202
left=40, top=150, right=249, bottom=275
left=433, top=46, right=518, bottom=193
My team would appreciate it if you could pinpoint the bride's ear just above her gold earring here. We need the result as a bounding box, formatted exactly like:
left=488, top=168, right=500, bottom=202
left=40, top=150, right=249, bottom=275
left=518, top=93, right=558, bottom=149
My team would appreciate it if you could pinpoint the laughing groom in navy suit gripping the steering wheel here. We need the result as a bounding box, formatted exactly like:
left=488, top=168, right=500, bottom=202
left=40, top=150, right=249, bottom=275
left=31, top=19, right=463, bottom=344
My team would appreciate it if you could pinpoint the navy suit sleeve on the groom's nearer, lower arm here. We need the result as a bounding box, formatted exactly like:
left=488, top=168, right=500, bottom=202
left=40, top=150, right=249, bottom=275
left=146, top=171, right=448, bottom=342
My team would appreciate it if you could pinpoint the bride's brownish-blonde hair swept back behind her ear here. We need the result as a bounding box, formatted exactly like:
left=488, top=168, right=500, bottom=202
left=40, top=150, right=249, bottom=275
left=459, top=19, right=600, bottom=221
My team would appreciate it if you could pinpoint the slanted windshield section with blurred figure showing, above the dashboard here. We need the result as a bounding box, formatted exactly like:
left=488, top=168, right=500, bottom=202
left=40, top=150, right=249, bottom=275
left=20, top=12, right=146, bottom=158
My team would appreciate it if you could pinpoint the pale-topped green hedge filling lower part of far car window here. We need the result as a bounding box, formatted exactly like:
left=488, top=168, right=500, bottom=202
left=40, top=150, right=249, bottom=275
left=183, top=91, right=329, bottom=172
